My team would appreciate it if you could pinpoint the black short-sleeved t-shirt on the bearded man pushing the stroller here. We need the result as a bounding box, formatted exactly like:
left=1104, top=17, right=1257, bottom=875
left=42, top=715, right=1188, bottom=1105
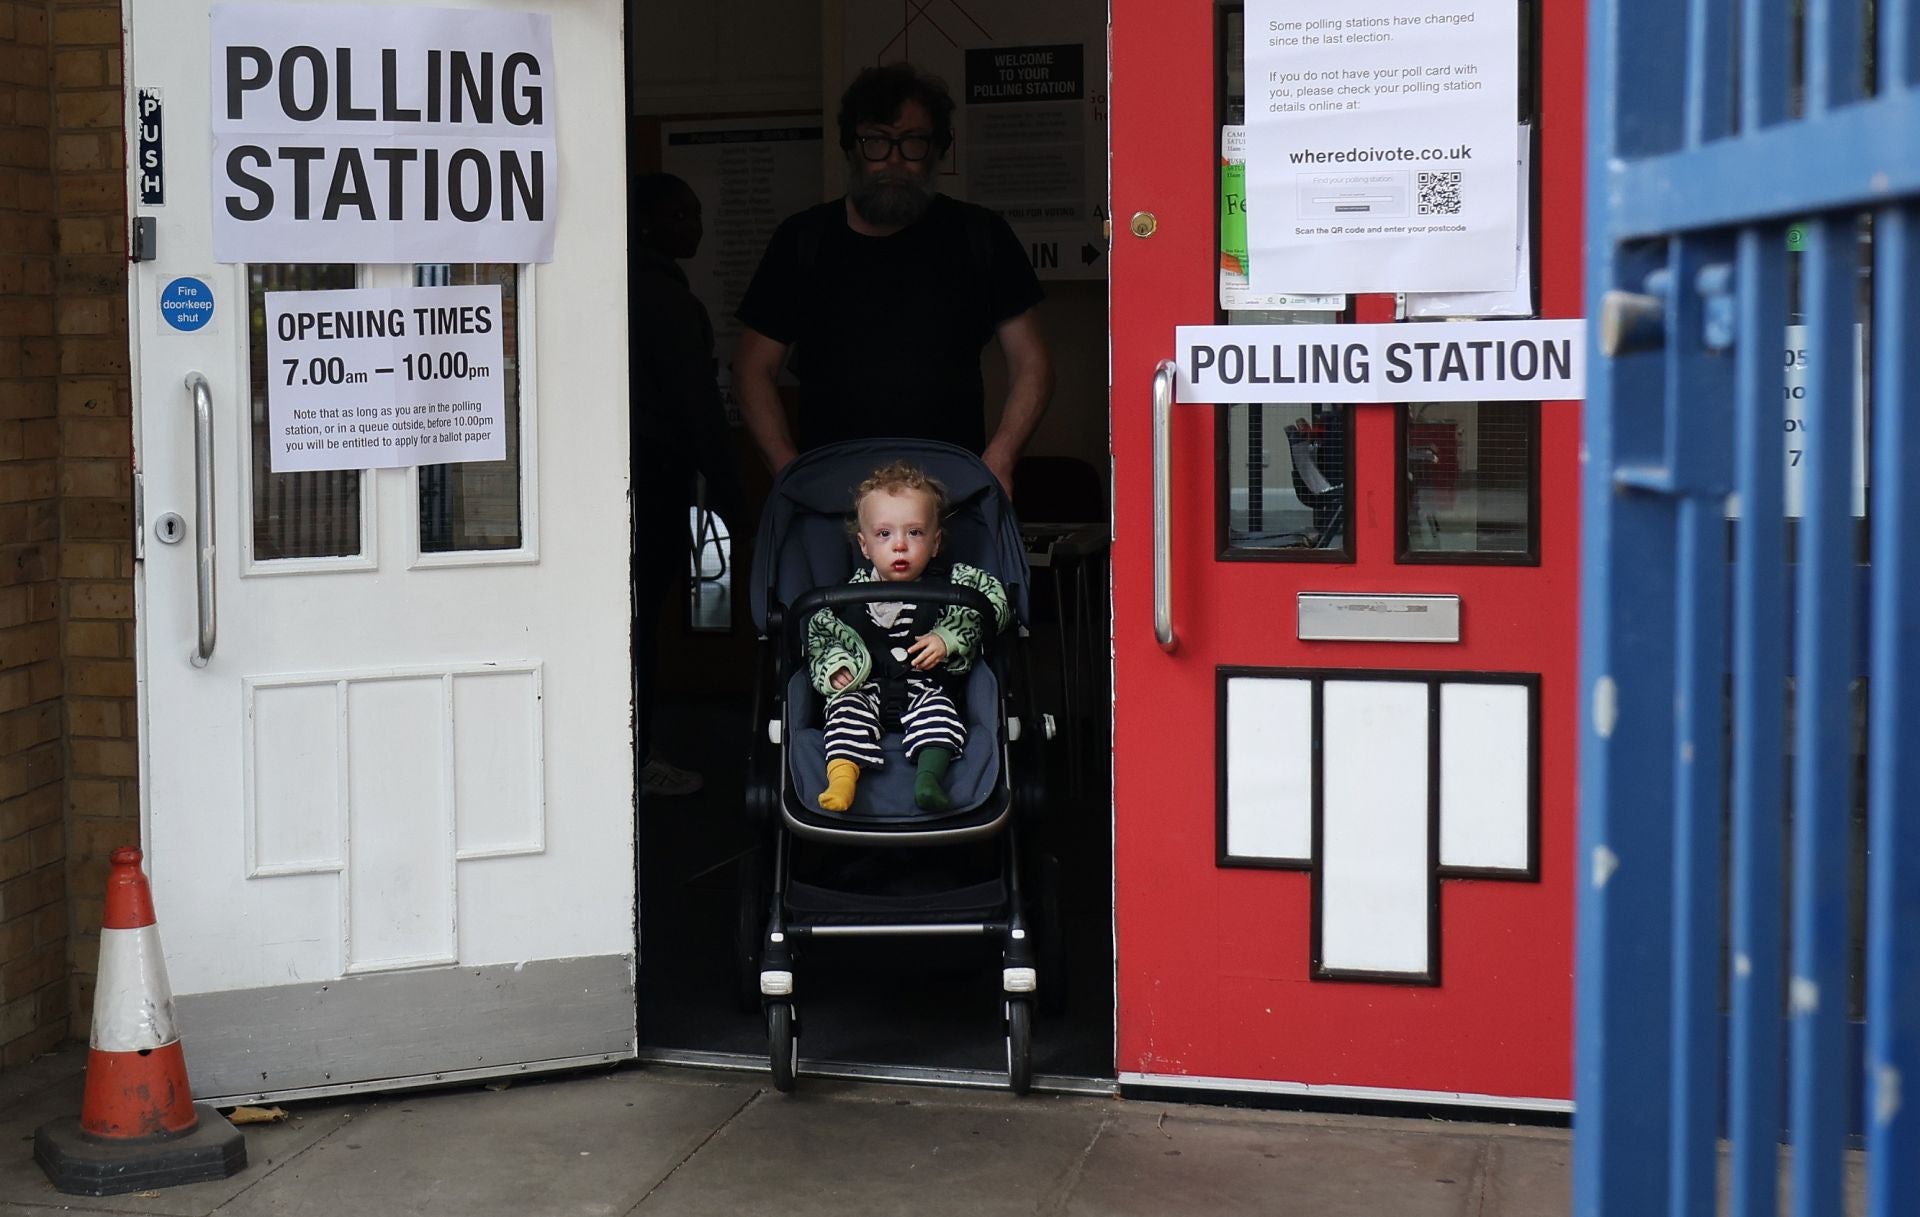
left=737, top=196, right=1041, bottom=453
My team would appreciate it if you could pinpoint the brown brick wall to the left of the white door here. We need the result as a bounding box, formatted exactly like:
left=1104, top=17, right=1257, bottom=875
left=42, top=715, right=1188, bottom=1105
left=0, top=0, right=138, bottom=1067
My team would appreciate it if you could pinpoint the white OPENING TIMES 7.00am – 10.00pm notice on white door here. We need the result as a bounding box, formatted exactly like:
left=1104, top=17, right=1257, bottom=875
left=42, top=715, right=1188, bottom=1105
left=267, top=284, right=507, bottom=474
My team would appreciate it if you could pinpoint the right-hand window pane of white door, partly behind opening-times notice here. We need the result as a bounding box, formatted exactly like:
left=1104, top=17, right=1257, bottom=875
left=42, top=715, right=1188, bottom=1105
left=413, top=263, right=522, bottom=553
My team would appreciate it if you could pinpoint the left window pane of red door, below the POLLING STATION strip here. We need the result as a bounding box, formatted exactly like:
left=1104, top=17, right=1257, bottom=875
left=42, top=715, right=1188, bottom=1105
left=1223, top=403, right=1352, bottom=561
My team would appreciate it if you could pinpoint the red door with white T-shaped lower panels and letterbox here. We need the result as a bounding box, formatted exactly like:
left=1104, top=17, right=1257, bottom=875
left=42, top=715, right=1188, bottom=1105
left=1112, top=0, right=1584, bottom=1100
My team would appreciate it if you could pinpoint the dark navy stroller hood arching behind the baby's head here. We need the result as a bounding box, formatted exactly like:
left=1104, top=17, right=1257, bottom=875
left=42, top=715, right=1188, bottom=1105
left=749, top=440, right=1027, bottom=633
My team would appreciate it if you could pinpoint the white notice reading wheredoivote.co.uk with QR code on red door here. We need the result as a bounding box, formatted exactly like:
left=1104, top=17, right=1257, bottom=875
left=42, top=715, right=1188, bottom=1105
left=1246, top=0, right=1519, bottom=292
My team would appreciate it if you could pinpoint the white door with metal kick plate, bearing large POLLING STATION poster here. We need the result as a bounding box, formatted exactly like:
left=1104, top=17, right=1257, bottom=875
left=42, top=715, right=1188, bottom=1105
left=127, top=0, right=634, bottom=1100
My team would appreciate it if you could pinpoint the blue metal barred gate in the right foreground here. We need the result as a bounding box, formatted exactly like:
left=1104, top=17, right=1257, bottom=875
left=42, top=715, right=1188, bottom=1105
left=1574, top=0, right=1920, bottom=1217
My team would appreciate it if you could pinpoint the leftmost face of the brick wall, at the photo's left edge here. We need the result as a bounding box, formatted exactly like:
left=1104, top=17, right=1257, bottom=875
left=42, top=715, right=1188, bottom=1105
left=0, top=0, right=69, bottom=1065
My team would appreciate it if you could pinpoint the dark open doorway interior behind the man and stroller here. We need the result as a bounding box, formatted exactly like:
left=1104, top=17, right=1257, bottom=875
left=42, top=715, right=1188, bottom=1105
left=628, top=0, right=1114, bottom=1085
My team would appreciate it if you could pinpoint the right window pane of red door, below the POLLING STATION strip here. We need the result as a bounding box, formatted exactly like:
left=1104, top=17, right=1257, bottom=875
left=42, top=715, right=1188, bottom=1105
left=1400, top=401, right=1540, bottom=562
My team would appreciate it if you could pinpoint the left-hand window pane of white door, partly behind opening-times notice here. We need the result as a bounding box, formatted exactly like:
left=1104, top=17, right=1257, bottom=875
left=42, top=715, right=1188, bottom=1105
left=248, top=263, right=361, bottom=562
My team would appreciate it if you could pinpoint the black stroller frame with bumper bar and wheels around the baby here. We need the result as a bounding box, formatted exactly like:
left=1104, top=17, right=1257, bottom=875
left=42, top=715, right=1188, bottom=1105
left=735, top=441, right=1064, bottom=1094
